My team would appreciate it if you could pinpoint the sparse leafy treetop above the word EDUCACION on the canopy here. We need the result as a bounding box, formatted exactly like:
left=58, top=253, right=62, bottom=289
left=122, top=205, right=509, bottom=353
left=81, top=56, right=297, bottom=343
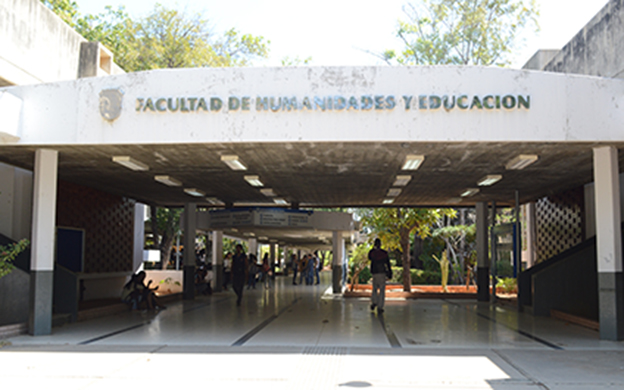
left=380, top=0, right=539, bottom=66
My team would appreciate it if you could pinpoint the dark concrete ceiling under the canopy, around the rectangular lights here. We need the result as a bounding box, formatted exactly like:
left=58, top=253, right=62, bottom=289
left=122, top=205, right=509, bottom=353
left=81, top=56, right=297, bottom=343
left=0, top=139, right=624, bottom=207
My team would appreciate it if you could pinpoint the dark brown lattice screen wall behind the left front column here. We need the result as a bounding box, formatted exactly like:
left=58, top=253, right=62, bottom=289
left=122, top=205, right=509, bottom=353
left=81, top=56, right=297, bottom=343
left=56, top=181, right=135, bottom=272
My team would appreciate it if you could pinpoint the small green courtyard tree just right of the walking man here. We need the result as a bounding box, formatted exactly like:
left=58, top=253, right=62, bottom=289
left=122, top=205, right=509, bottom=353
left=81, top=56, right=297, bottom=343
left=362, top=208, right=456, bottom=292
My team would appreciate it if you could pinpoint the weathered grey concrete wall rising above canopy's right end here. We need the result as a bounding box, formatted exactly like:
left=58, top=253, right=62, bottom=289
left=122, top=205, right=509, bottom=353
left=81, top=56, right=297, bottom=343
left=543, top=0, right=624, bottom=78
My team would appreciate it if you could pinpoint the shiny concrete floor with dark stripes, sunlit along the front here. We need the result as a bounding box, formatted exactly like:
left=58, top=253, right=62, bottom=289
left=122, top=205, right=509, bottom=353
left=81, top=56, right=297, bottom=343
left=0, top=273, right=624, bottom=390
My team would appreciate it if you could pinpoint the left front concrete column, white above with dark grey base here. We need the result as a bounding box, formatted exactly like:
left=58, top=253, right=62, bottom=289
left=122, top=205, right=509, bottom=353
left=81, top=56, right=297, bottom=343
left=28, top=149, right=58, bottom=336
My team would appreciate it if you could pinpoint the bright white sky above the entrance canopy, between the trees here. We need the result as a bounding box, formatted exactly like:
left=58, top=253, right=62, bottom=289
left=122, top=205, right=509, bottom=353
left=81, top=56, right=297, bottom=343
left=75, top=0, right=608, bottom=68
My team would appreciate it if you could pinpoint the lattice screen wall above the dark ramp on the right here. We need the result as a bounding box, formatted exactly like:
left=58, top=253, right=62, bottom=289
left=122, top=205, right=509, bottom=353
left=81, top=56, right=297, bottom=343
left=535, top=187, right=584, bottom=263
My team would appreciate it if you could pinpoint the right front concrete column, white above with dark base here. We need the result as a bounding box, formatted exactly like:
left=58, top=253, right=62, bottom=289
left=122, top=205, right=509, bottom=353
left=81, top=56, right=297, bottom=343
left=594, top=146, right=624, bottom=341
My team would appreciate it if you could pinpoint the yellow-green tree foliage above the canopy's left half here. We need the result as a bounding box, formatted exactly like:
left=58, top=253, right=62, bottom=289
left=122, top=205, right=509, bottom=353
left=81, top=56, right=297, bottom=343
left=41, top=0, right=269, bottom=72
